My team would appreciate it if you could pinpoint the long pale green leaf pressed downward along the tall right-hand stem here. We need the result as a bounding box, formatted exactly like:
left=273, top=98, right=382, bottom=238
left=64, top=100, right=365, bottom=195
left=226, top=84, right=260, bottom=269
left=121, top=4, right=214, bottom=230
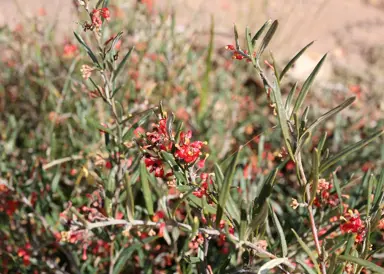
left=272, top=78, right=296, bottom=162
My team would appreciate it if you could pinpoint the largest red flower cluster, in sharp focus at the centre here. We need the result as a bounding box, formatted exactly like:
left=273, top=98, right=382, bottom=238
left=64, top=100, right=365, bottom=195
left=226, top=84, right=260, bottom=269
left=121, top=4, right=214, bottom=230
left=141, top=118, right=206, bottom=180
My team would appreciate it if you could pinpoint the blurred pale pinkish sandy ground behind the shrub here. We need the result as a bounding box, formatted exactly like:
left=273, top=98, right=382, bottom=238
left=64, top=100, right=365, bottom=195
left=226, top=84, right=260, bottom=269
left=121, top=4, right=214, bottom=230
left=0, top=0, right=384, bottom=77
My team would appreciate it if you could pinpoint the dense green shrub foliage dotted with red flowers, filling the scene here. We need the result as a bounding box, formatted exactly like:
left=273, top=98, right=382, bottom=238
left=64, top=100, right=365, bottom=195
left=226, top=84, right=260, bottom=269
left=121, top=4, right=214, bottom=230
left=0, top=0, right=384, bottom=273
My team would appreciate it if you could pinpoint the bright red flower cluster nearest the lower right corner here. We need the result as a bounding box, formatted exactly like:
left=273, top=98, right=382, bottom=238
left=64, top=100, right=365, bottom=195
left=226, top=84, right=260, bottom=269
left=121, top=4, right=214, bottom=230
left=340, top=209, right=365, bottom=243
